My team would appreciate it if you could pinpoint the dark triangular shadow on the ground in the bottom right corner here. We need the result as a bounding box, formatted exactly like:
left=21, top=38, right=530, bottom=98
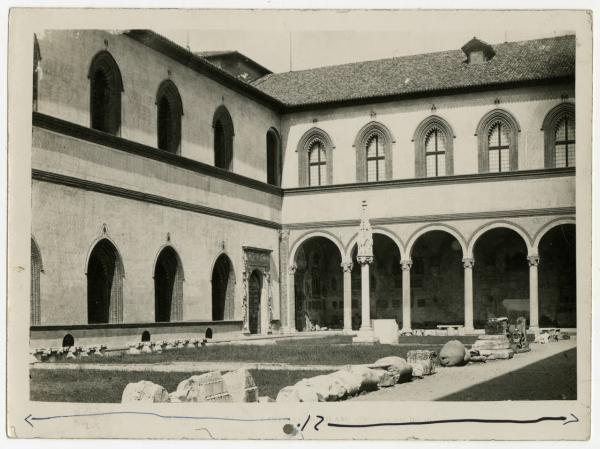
left=438, top=348, right=577, bottom=401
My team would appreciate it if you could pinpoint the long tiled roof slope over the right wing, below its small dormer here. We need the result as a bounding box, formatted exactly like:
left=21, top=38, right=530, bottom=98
left=252, top=35, right=575, bottom=106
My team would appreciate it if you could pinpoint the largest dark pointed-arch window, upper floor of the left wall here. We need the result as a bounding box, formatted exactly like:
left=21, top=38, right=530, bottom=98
left=88, top=51, right=123, bottom=135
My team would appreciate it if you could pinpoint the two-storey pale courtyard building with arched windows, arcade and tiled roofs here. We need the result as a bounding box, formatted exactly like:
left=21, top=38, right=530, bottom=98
left=31, top=30, right=576, bottom=346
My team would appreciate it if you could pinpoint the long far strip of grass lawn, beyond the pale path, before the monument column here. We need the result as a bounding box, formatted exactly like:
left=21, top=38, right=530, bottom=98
left=57, top=336, right=476, bottom=365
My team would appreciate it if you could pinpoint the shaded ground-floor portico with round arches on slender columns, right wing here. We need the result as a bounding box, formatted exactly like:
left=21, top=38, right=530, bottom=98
left=287, top=212, right=576, bottom=333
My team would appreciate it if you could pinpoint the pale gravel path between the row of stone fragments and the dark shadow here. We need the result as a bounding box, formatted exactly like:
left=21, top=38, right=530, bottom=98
left=352, top=337, right=577, bottom=401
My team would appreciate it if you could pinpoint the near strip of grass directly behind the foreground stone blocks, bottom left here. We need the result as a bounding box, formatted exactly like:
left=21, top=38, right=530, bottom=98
left=29, top=369, right=327, bottom=403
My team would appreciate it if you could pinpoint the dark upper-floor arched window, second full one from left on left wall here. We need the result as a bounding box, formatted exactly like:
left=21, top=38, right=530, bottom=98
left=156, top=80, right=183, bottom=154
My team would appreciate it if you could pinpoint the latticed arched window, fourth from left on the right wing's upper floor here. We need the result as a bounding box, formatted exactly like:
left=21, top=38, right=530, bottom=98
left=475, top=109, right=521, bottom=173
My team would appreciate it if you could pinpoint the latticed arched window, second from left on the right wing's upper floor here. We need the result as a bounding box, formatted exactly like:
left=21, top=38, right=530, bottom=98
left=354, top=122, right=394, bottom=182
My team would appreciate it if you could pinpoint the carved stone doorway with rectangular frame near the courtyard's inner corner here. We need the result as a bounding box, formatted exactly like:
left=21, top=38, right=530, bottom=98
left=242, top=246, right=273, bottom=334
